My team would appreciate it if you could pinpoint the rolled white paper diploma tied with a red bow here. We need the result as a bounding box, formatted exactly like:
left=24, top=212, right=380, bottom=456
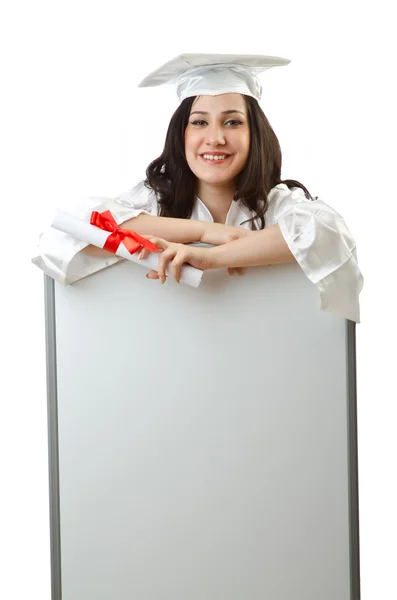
left=51, top=210, right=203, bottom=288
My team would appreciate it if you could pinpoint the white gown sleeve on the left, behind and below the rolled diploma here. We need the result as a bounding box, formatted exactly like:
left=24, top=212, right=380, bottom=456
left=32, top=181, right=157, bottom=285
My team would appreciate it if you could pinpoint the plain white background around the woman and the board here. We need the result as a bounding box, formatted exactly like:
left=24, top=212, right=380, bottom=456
left=0, top=0, right=397, bottom=600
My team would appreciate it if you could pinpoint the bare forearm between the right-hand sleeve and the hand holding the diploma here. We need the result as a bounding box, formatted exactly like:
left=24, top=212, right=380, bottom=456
left=209, top=225, right=295, bottom=268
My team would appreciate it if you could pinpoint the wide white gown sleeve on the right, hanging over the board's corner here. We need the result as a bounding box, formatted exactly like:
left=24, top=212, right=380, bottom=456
left=268, top=184, right=364, bottom=323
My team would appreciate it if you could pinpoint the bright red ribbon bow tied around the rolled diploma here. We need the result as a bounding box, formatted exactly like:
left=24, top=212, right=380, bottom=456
left=90, top=210, right=159, bottom=254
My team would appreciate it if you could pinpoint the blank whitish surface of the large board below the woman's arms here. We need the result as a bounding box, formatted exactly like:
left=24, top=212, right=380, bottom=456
left=51, top=262, right=350, bottom=600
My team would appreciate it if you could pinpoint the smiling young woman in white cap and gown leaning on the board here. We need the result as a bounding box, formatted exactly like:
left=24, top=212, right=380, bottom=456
left=34, top=55, right=362, bottom=321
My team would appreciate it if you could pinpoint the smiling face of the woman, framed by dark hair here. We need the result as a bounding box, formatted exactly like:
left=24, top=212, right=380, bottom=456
left=185, top=94, right=250, bottom=185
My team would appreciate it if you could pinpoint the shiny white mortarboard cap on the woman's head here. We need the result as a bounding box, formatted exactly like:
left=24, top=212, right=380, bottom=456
left=138, top=54, right=291, bottom=102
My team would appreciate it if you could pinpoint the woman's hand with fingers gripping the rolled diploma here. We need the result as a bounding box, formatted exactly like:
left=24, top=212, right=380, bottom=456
left=139, top=235, right=216, bottom=283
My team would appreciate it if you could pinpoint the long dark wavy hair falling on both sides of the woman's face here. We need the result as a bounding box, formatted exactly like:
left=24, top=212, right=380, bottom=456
left=145, top=95, right=313, bottom=229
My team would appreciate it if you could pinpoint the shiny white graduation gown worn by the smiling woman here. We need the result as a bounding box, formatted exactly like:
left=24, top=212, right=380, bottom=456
left=33, top=181, right=363, bottom=322
